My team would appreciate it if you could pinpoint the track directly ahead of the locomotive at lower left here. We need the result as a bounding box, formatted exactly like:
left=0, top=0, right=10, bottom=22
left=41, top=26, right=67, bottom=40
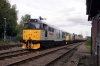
left=0, top=49, right=38, bottom=66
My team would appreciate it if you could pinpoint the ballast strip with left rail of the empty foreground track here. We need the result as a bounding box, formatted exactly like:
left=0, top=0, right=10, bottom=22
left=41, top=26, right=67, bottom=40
left=0, top=42, right=80, bottom=66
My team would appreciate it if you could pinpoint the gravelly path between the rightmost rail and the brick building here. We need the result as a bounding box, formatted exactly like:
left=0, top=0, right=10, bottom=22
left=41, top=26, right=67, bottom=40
left=67, top=44, right=95, bottom=66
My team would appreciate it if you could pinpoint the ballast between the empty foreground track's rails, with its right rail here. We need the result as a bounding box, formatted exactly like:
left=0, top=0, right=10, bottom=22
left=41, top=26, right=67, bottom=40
left=21, top=44, right=80, bottom=66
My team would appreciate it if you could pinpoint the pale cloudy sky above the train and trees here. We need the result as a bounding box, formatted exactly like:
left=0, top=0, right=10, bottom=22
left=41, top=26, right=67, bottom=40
left=9, top=0, right=91, bottom=37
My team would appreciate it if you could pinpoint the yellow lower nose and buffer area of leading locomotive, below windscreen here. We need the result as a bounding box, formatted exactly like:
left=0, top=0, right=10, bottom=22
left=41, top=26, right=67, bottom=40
left=22, top=29, right=41, bottom=49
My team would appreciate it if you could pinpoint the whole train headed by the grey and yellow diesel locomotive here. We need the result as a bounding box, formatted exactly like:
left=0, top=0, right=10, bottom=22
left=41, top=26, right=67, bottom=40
left=22, top=19, right=84, bottom=49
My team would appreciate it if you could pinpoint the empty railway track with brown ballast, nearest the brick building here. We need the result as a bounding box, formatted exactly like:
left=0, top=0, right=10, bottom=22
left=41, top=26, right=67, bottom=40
left=0, top=44, right=83, bottom=66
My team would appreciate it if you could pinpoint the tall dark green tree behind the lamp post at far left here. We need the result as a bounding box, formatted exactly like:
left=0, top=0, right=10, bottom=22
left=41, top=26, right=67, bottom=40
left=0, top=0, right=18, bottom=37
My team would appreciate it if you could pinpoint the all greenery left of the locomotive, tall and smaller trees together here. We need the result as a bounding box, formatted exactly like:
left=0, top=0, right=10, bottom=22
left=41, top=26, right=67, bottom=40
left=0, top=0, right=31, bottom=44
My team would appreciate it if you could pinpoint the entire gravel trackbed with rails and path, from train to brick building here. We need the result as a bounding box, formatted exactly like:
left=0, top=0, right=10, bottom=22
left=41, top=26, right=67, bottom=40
left=0, top=42, right=90, bottom=66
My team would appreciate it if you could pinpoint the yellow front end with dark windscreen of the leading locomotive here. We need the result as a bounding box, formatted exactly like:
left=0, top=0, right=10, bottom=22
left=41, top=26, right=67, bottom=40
left=22, top=19, right=41, bottom=49
